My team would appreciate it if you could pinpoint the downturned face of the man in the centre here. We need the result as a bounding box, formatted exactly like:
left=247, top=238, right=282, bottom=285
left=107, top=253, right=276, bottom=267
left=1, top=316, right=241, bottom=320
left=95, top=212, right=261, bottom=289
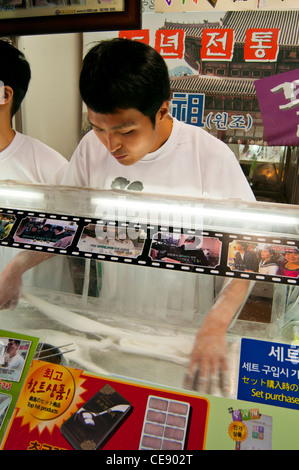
left=88, top=102, right=171, bottom=166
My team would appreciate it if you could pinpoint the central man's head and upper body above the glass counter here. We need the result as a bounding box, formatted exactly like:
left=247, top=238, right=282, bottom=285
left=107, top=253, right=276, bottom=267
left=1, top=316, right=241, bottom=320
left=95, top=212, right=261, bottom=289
left=62, top=35, right=254, bottom=200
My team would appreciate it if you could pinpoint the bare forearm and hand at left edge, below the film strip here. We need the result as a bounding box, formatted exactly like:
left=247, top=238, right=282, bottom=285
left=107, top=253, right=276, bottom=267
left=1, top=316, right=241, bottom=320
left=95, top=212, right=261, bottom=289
left=0, top=251, right=55, bottom=310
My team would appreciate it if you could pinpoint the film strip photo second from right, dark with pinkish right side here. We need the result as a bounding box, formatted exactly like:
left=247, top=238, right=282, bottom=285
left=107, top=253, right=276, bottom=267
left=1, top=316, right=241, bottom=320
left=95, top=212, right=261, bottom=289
left=149, top=231, right=222, bottom=268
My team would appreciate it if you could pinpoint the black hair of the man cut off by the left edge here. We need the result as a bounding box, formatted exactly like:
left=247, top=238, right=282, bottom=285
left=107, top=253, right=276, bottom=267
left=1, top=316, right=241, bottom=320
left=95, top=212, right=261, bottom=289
left=0, top=40, right=31, bottom=117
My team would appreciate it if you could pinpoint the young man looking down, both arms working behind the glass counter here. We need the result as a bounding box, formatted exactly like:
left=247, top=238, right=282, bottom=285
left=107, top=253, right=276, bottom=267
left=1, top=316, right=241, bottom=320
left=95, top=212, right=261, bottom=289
left=0, top=39, right=254, bottom=391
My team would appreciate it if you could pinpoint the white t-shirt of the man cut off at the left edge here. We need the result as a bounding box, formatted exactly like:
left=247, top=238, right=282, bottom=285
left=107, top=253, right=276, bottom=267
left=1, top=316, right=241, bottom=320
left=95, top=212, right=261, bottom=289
left=0, top=131, right=72, bottom=291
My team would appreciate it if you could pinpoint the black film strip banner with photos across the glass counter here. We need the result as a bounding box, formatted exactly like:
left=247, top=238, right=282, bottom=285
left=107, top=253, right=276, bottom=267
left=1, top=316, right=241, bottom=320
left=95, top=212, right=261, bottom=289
left=0, top=208, right=299, bottom=285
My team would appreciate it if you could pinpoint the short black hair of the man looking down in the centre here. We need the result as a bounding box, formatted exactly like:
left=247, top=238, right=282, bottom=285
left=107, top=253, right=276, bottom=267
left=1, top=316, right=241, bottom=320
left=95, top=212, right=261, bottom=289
left=80, top=38, right=170, bottom=124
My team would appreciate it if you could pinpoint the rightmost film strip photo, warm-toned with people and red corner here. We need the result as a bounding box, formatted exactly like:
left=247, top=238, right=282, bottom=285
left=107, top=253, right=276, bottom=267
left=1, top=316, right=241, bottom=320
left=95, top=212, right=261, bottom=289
left=227, top=239, right=299, bottom=278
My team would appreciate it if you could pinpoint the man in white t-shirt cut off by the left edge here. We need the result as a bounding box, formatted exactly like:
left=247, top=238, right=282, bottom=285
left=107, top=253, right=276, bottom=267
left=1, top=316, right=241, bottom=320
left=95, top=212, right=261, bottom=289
left=0, top=40, right=72, bottom=298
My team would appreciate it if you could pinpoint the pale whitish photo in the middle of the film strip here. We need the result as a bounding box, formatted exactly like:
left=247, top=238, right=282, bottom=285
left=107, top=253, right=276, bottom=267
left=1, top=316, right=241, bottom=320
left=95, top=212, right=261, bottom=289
left=77, top=222, right=146, bottom=258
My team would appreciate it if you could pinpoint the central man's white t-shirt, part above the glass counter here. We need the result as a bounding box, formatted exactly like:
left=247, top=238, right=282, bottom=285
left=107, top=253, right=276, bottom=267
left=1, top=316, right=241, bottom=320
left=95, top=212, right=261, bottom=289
left=62, top=119, right=254, bottom=200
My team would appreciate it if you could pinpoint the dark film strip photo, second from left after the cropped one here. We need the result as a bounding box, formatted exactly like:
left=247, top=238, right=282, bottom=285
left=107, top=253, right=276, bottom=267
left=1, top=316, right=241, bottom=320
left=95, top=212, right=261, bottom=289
left=13, top=217, right=78, bottom=249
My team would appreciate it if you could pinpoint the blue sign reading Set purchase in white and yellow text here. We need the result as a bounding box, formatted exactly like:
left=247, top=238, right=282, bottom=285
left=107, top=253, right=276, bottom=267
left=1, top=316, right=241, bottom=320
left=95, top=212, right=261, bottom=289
left=238, top=338, right=299, bottom=410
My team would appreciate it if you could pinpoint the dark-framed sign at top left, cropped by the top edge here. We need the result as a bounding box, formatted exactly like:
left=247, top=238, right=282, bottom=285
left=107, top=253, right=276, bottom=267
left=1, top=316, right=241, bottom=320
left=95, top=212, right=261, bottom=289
left=0, top=0, right=141, bottom=36
